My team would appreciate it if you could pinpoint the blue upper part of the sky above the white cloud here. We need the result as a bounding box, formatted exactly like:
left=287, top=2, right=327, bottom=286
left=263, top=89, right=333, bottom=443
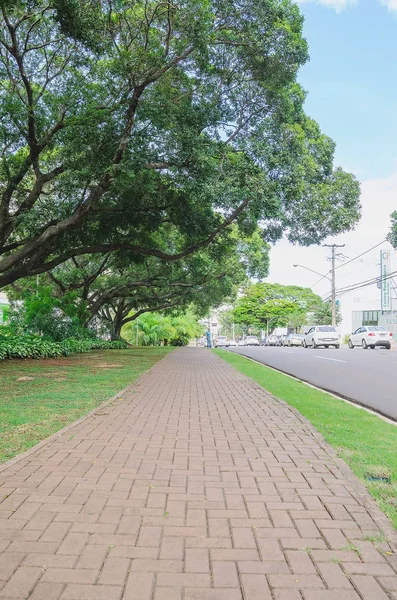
left=299, top=0, right=397, bottom=178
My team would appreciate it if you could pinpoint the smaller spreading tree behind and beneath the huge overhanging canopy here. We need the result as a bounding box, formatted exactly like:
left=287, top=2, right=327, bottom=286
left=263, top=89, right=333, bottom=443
left=9, top=226, right=269, bottom=338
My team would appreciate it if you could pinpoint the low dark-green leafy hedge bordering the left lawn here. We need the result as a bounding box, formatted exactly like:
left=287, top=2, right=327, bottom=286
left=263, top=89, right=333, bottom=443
left=0, top=335, right=128, bottom=360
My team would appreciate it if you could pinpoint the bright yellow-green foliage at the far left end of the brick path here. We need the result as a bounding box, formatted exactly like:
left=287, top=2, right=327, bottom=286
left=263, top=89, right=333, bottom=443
left=122, top=311, right=203, bottom=346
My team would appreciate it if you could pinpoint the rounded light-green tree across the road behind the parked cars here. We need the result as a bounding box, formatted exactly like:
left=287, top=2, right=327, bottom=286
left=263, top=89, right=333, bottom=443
left=233, top=283, right=322, bottom=330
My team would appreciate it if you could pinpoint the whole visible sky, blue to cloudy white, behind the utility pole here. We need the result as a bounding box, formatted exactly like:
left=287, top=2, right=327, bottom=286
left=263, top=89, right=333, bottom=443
left=268, top=0, right=397, bottom=333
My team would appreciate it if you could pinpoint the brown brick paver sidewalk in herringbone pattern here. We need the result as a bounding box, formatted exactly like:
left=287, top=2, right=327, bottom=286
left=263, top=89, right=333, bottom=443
left=0, top=348, right=397, bottom=600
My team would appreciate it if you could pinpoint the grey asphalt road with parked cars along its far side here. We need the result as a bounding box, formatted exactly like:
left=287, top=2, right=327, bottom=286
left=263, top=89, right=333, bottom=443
left=230, top=346, right=397, bottom=421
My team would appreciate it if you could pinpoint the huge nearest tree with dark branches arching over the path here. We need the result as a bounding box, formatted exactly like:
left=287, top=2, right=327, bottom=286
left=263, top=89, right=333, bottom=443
left=0, top=0, right=359, bottom=287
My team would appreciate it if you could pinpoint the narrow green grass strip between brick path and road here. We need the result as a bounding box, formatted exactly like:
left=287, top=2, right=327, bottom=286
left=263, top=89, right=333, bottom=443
left=214, top=350, right=397, bottom=529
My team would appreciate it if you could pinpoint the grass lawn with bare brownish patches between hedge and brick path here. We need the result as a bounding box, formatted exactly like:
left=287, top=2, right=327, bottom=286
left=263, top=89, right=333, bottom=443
left=0, top=347, right=173, bottom=462
